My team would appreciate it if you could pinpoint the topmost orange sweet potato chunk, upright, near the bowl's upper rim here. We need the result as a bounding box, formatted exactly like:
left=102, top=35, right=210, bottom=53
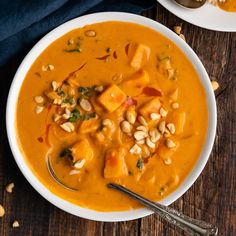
left=130, top=44, right=150, bottom=70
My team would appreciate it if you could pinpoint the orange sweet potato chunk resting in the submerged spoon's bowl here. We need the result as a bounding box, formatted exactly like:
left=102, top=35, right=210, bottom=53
left=70, top=139, right=93, bottom=162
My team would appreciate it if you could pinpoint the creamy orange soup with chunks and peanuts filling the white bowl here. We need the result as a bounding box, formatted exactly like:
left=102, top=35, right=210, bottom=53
left=16, top=22, right=208, bottom=211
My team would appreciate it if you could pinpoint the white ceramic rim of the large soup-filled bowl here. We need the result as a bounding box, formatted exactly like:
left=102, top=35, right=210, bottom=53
left=6, top=12, right=216, bottom=221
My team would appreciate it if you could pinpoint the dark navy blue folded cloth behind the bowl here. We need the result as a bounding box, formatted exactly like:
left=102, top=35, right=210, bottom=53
left=0, top=0, right=156, bottom=67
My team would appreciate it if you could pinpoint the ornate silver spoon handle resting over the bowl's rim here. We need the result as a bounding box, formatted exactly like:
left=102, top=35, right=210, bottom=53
left=107, top=183, right=218, bottom=236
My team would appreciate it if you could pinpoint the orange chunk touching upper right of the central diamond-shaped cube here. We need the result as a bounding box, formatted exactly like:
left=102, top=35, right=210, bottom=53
left=121, top=70, right=150, bottom=96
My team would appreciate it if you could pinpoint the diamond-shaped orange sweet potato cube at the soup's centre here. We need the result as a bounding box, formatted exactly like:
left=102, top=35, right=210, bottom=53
left=98, top=84, right=126, bottom=112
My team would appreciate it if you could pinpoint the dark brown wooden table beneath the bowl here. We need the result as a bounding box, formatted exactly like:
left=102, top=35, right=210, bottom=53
left=0, top=4, right=236, bottom=236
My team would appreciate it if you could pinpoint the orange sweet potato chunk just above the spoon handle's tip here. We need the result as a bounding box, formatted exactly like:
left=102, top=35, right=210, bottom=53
left=104, top=149, right=128, bottom=179
